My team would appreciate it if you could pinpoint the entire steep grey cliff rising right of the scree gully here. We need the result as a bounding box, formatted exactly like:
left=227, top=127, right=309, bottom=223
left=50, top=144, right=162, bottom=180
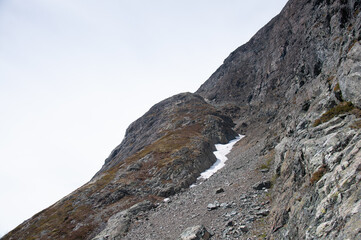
left=197, top=0, right=361, bottom=239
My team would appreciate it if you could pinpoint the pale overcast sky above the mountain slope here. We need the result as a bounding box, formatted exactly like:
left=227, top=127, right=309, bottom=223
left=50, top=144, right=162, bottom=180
left=0, top=0, right=287, bottom=236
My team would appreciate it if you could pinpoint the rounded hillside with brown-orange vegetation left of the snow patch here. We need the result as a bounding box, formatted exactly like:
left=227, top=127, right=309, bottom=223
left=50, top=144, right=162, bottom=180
left=3, top=93, right=237, bottom=240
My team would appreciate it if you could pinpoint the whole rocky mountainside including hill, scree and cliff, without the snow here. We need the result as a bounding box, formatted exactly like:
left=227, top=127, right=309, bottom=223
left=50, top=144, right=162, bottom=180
left=2, top=0, right=361, bottom=240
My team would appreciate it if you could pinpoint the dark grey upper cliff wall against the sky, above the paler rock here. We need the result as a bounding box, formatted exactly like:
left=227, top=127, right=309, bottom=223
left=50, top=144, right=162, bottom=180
left=197, top=1, right=360, bottom=131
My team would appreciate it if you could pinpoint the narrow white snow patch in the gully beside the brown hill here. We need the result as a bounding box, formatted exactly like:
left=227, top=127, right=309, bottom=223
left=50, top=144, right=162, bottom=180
left=191, top=135, right=244, bottom=187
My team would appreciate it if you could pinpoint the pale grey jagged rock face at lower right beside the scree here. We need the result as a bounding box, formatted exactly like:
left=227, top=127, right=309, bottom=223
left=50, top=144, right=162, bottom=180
left=271, top=114, right=361, bottom=239
